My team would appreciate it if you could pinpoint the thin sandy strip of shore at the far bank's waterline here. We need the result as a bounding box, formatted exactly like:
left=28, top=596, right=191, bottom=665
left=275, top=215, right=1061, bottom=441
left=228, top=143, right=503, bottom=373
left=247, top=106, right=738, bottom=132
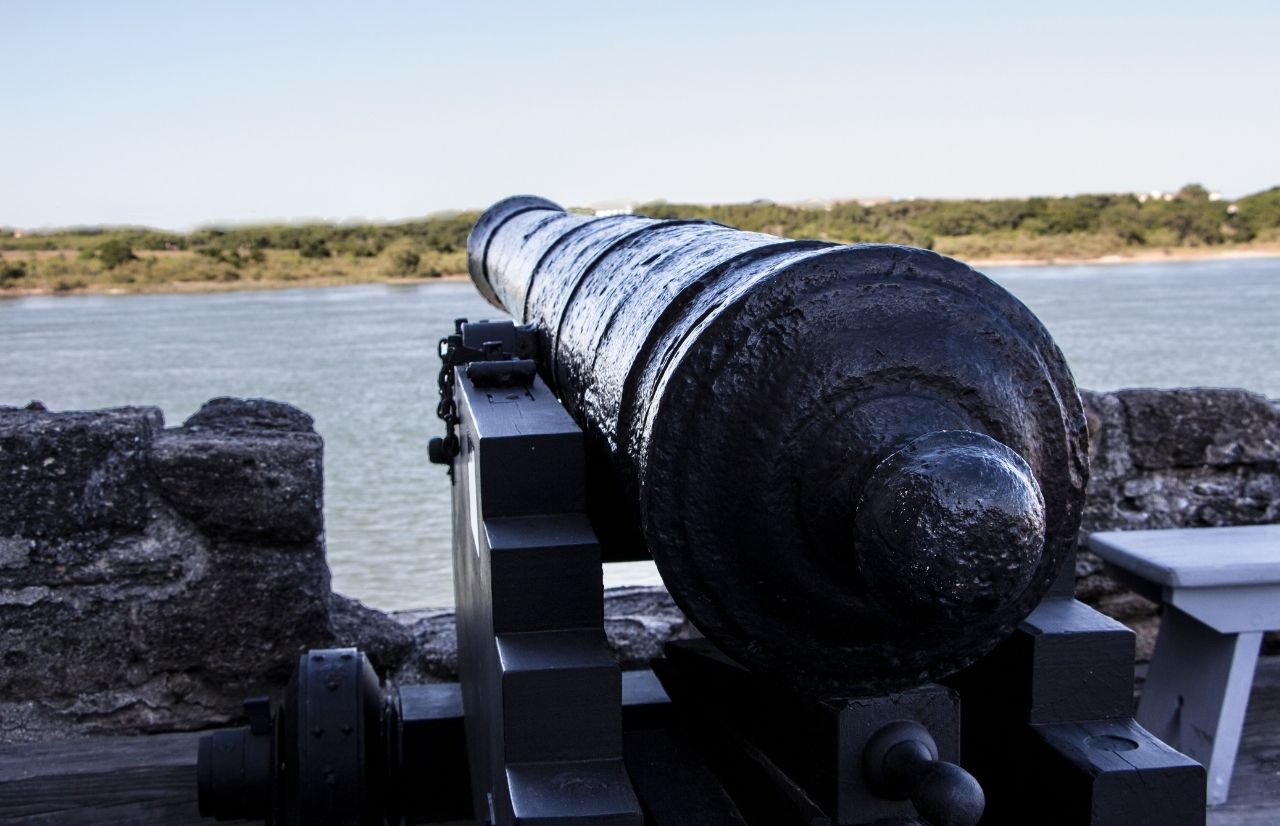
left=0, top=245, right=1280, bottom=300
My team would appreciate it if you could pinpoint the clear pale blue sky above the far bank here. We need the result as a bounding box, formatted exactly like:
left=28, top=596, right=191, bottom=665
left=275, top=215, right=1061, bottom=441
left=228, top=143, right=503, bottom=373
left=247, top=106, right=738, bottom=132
left=0, top=0, right=1280, bottom=229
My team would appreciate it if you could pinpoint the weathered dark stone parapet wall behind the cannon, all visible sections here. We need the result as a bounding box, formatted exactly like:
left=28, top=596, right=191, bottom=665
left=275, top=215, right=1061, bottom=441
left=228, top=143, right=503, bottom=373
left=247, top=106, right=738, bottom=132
left=0, top=389, right=1280, bottom=741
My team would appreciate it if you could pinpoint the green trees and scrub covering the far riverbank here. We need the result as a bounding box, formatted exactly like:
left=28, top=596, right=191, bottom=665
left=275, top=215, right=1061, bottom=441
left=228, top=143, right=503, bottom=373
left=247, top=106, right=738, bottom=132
left=0, top=184, right=1280, bottom=288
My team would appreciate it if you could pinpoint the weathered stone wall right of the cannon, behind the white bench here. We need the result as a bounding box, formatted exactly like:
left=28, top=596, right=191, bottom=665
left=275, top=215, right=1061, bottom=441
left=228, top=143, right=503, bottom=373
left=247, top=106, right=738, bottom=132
left=1076, top=388, right=1280, bottom=657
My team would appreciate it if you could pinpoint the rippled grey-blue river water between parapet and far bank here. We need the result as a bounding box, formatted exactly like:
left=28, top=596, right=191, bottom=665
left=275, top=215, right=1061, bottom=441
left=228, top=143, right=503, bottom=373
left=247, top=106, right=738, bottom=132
left=0, top=259, right=1280, bottom=608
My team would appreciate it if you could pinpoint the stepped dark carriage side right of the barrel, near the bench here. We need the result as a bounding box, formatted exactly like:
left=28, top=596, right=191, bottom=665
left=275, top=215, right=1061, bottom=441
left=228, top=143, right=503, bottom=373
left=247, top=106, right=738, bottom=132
left=947, top=590, right=1204, bottom=826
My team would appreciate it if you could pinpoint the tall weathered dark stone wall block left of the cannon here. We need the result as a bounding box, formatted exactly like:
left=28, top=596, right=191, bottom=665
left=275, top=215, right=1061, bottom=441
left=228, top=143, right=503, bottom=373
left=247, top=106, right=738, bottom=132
left=0, top=400, right=332, bottom=739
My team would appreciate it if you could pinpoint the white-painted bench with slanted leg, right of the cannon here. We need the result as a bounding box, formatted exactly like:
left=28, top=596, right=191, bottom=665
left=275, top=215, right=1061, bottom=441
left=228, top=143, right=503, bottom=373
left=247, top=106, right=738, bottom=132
left=1089, top=525, right=1280, bottom=806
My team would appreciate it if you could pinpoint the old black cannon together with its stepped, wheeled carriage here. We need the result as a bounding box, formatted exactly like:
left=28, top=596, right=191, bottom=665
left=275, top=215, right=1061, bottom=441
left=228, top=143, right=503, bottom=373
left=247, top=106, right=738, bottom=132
left=200, top=196, right=1204, bottom=826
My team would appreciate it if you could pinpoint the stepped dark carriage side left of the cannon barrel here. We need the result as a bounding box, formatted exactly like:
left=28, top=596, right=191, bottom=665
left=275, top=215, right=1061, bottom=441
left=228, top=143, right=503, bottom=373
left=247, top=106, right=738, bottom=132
left=453, top=350, right=644, bottom=826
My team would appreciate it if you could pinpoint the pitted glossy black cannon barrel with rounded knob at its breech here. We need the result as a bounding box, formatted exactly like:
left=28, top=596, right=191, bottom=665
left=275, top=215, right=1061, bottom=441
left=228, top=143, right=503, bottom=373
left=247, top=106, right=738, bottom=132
left=467, top=196, right=1088, bottom=690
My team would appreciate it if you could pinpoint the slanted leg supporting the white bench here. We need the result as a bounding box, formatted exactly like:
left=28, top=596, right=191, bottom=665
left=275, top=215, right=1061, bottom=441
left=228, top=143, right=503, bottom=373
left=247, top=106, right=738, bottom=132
left=1137, top=604, right=1262, bottom=806
